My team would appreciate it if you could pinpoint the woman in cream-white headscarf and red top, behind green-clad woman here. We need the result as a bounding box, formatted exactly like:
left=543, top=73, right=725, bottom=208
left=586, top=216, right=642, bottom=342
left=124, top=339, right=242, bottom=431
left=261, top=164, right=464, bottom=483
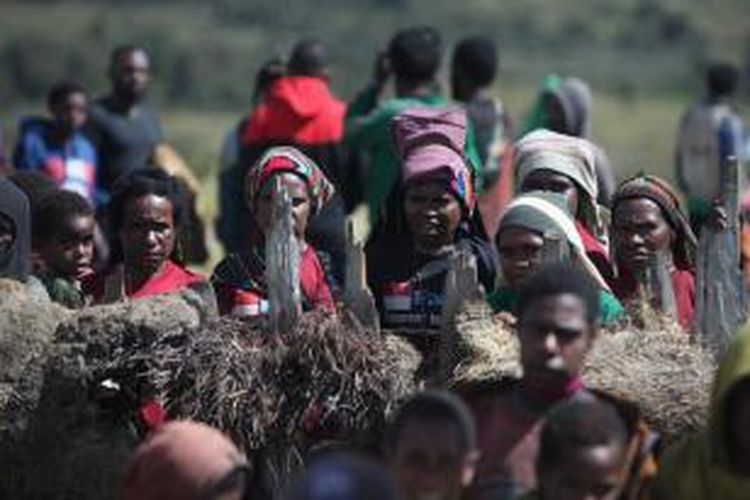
left=515, top=130, right=614, bottom=284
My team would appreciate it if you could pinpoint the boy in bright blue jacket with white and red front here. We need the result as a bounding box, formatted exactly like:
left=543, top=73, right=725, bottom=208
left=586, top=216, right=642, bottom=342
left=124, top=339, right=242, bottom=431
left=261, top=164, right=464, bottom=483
left=13, top=81, right=97, bottom=203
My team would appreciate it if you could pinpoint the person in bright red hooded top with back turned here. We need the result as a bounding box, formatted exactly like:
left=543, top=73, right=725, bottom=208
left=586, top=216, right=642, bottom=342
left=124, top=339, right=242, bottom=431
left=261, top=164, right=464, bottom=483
left=238, top=38, right=349, bottom=282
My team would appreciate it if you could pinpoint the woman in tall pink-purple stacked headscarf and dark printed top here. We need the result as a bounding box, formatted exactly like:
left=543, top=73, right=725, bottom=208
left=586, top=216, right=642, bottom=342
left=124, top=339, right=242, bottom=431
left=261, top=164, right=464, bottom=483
left=367, top=108, right=495, bottom=330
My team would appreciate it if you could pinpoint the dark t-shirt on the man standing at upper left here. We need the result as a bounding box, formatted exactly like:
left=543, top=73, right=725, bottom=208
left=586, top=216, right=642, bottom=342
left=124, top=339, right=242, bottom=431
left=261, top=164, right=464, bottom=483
left=89, top=97, right=163, bottom=192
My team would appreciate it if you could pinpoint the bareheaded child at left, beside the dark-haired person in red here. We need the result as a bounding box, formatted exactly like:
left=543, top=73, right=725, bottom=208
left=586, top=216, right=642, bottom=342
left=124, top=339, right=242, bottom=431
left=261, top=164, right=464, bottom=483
left=33, top=191, right=95, bottom=308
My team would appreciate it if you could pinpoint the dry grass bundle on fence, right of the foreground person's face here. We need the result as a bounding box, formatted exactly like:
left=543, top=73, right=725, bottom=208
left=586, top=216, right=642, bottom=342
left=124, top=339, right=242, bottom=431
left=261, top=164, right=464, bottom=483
left=584, top=323, right=716, bottom=441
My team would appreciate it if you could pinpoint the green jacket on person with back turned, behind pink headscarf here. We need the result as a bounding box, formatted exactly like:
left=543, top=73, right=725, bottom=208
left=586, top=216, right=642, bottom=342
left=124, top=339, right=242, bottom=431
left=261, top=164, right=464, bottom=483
left=344, top=87, right=480, bottom=226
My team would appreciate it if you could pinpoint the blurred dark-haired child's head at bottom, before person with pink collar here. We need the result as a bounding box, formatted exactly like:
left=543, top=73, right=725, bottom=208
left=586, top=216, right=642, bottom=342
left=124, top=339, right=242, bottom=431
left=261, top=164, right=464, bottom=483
left=527, top=397, right=630, bottom=500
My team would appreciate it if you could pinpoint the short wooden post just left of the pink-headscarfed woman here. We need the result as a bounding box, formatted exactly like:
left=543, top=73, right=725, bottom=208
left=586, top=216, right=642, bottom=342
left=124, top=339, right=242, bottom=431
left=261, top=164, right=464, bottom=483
left=344, top=220, right=380, bottom=332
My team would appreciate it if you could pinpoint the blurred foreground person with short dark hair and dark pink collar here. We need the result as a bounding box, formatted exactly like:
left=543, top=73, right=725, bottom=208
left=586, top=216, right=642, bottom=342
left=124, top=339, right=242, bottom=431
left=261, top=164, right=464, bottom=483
left=468, top=264, right=650, bottom=499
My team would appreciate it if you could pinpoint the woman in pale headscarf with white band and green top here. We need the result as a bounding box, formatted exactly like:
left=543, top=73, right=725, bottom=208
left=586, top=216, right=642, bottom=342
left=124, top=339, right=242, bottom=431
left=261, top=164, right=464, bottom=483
left=487, top=191, right=625, bottom=326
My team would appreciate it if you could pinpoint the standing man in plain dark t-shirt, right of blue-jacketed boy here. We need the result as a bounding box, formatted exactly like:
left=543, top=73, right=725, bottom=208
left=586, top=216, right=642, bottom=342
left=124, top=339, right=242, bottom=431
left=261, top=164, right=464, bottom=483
left=90, top=45, right=163, bottom=198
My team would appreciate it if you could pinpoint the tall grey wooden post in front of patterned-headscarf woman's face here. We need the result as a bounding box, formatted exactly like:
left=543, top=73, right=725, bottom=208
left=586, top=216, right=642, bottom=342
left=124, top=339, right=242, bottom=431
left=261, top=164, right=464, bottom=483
left=266, top=177, right=302, bottom=333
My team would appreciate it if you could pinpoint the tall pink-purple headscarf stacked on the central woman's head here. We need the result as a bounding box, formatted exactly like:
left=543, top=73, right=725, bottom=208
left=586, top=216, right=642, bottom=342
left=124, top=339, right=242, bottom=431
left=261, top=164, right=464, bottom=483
left=391, top=107, right=475, bottom=213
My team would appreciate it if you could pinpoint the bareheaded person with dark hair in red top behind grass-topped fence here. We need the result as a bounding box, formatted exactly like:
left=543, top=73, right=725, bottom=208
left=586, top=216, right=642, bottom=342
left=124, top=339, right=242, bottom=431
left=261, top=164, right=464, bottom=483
left=88, top=168, right=205, bottom=303
